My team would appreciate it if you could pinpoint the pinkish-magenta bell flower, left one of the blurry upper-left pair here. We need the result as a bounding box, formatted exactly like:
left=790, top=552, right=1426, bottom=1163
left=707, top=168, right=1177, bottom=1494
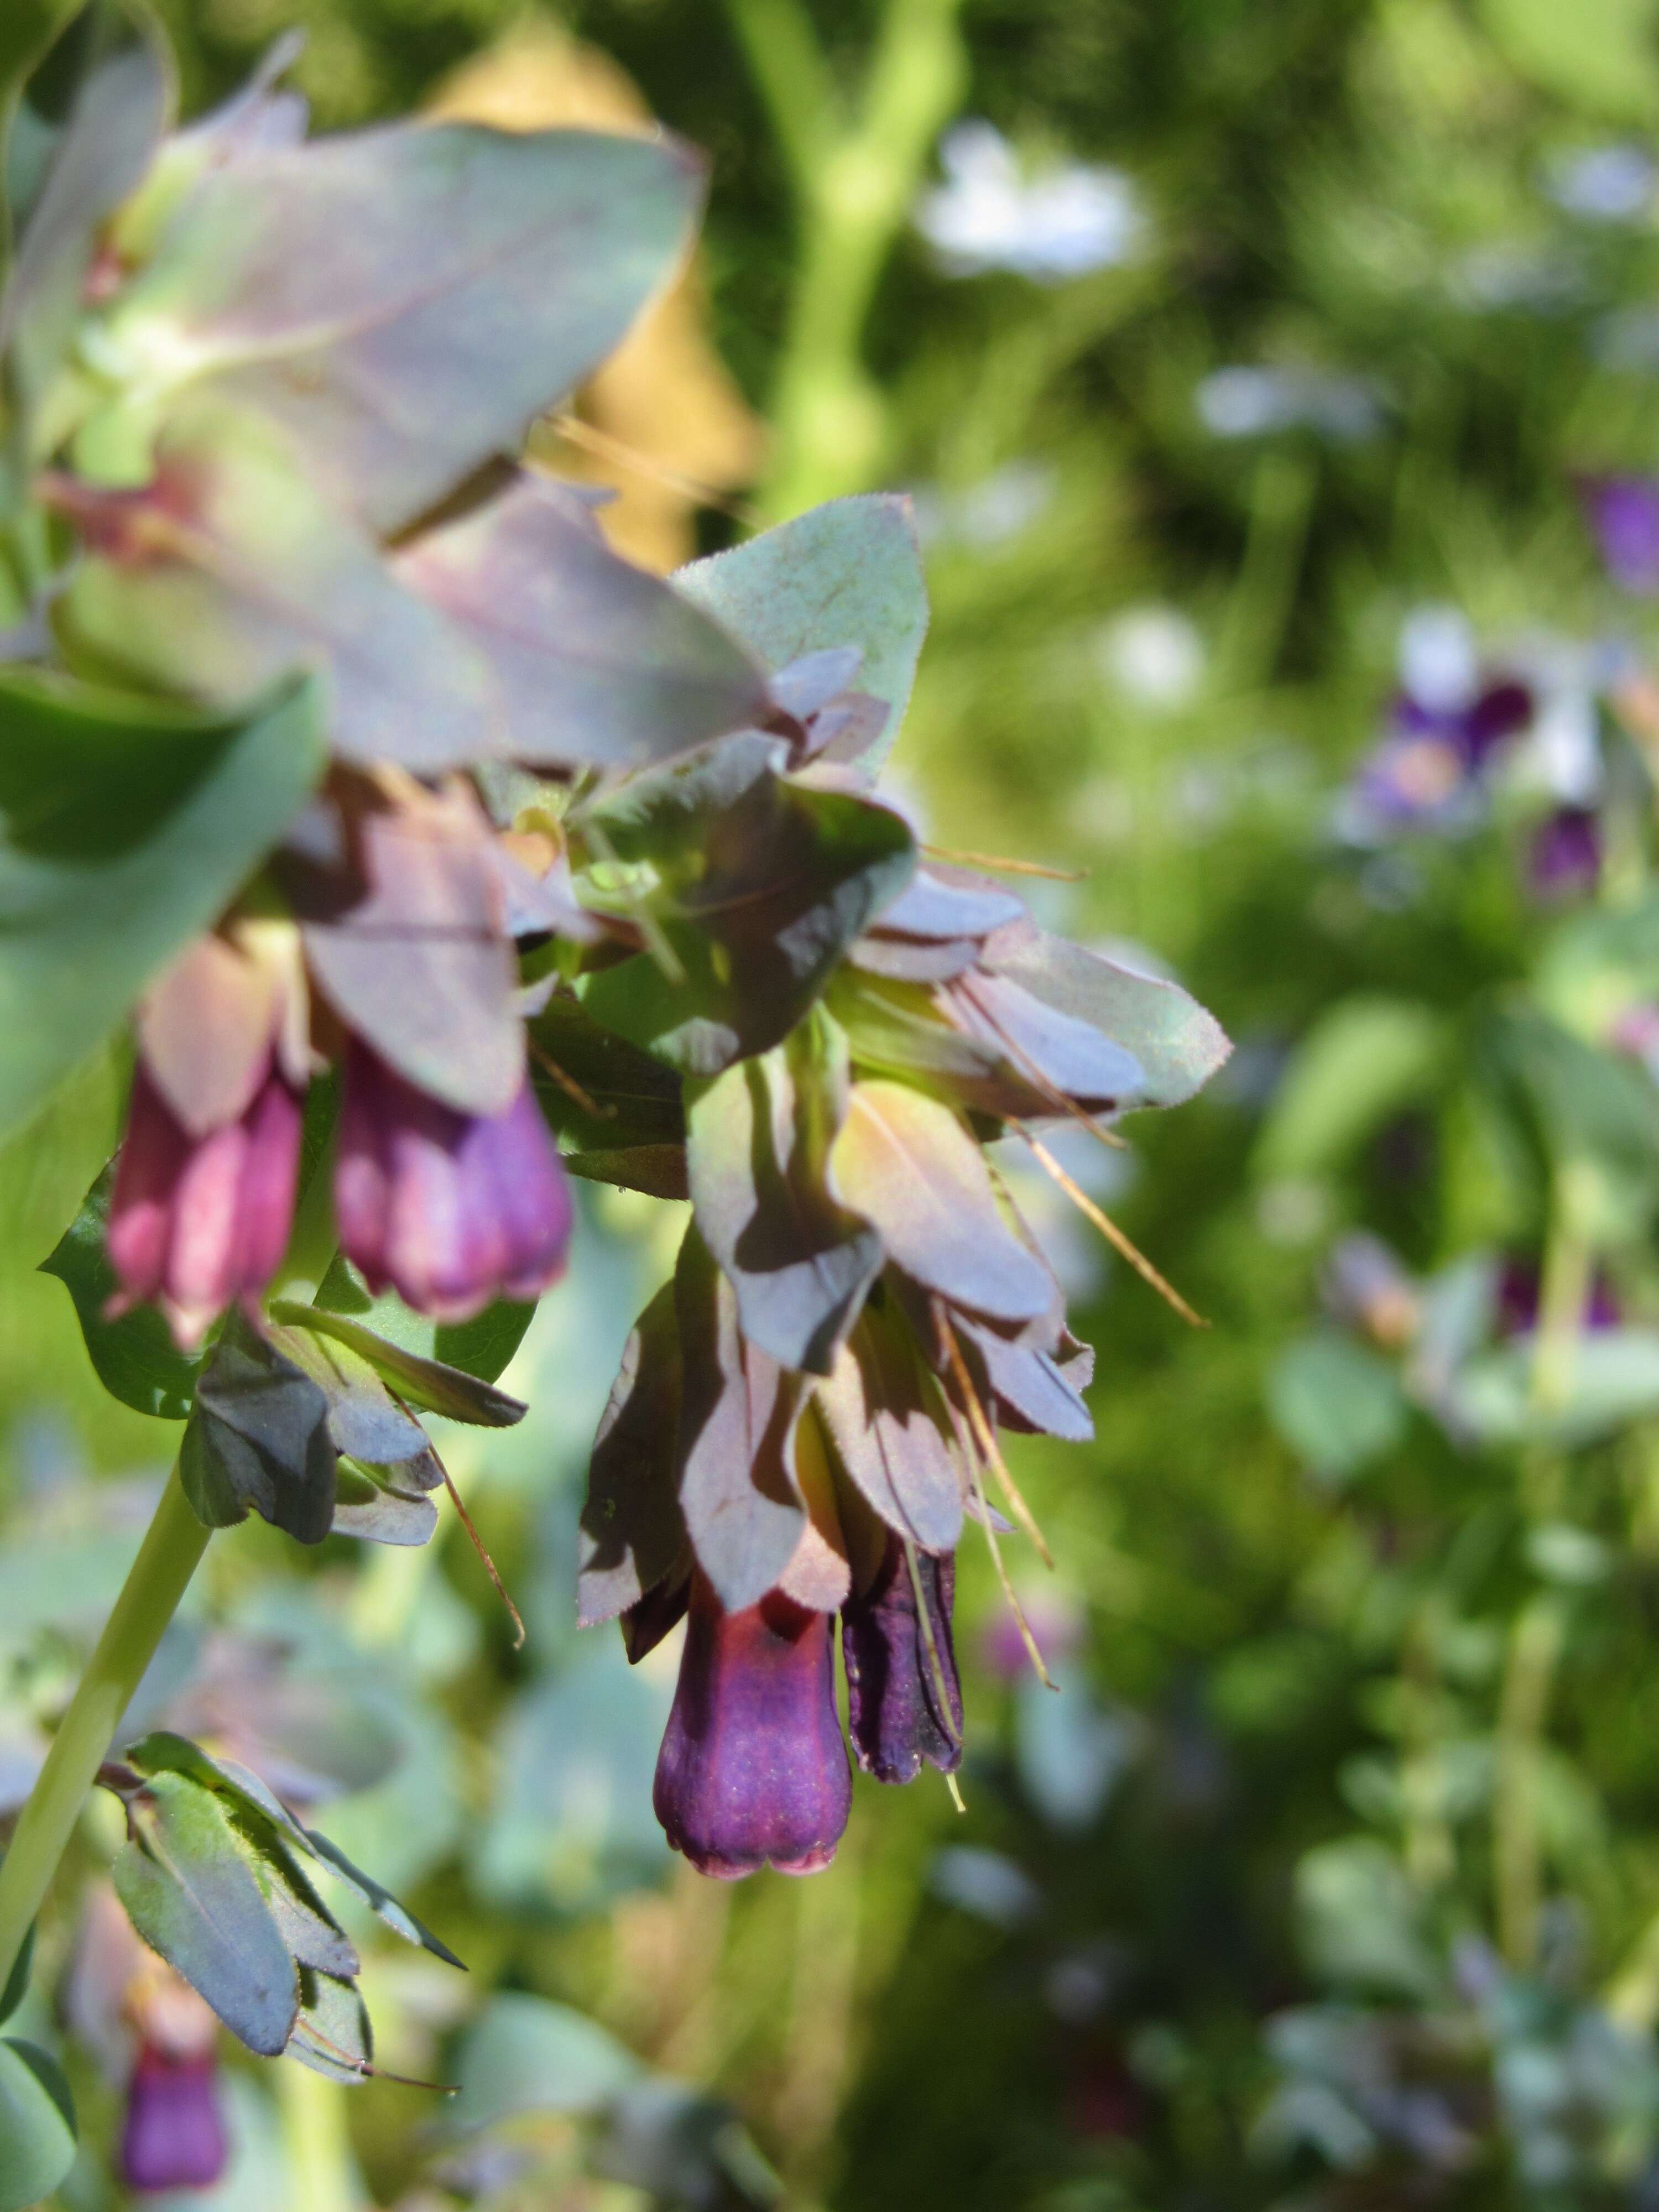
left=108, top=1060, right=301, bottom=1349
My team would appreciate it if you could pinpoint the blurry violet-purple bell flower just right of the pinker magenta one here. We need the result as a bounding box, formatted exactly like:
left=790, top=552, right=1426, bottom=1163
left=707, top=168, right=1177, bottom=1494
left=334, top=1037, right=571, bottom=1321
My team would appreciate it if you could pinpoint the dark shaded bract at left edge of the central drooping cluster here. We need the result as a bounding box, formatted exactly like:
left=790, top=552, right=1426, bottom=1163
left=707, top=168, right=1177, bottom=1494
left=575, top=1283, right=686, bottom=1628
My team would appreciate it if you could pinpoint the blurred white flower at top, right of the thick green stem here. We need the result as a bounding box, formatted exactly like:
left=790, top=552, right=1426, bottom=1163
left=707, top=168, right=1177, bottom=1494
left=916, top=119, right=1146, bottom=283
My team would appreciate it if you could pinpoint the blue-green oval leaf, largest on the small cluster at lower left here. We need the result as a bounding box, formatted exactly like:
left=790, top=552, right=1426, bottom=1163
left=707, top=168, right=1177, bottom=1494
left=115, top=1772, right=299, bottom=2057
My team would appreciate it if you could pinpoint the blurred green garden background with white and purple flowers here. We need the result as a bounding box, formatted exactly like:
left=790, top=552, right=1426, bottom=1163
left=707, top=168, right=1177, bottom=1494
left=23, top=0, right=1659, bottom=2212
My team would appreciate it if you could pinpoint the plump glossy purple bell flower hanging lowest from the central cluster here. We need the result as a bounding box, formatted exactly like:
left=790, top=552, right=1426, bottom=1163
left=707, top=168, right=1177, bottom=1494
left=650, top=1573, right=852, bottom=1882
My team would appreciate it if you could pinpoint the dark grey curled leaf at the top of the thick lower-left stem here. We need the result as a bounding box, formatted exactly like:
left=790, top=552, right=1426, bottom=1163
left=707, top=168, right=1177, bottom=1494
left=179, top=1314, right=334, bottom=1544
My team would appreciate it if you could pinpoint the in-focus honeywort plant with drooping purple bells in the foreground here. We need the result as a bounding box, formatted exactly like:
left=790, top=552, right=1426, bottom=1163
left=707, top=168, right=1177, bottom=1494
left=0, top=9, right=1225, bottom=2205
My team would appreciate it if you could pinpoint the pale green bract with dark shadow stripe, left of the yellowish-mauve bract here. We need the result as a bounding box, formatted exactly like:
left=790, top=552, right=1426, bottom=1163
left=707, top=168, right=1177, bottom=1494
left=686, top=1020, right=883, bottom=1374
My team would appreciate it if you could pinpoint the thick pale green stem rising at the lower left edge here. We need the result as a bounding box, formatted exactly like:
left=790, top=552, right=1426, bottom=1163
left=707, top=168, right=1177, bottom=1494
left=0, top=1467, right=212, bottom=1986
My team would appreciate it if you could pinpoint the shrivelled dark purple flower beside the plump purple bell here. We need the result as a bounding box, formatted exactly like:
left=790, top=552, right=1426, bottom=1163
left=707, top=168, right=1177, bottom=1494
left=841, top=1533, right=962, bottom=1783
